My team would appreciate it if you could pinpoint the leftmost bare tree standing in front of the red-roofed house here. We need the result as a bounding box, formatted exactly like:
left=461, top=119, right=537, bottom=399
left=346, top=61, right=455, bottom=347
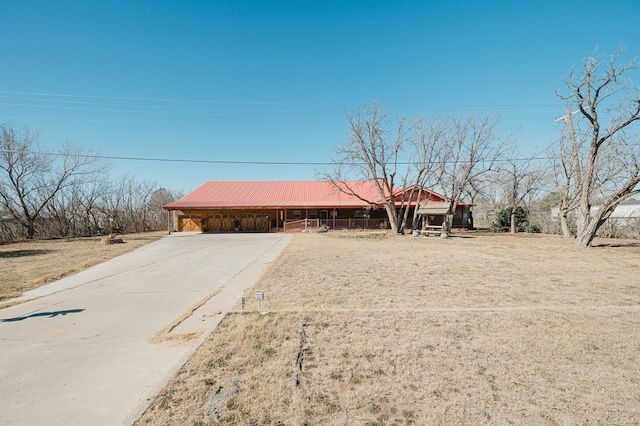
left=322, top=102, right=408, bottom=231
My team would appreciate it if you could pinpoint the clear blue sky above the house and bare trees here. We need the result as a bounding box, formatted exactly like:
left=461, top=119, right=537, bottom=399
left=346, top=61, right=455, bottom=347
left=0, top=0, right=640, bottom=191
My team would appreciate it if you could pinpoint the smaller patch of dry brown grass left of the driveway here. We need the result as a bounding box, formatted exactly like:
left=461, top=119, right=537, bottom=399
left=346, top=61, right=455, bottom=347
left=0, top=231, right=166, bottom=301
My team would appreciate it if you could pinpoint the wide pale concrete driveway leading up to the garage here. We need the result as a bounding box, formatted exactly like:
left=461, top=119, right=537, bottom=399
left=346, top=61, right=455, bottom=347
left=0, top=234, right=290, bottom=425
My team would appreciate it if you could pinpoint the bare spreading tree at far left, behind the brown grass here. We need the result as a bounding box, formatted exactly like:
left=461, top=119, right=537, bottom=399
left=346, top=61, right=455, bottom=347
left=0, top=125, right=101, bottom=239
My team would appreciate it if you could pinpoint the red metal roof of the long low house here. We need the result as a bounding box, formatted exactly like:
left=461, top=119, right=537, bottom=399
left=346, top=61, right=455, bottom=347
left=164, top=181, right=464, bottom=210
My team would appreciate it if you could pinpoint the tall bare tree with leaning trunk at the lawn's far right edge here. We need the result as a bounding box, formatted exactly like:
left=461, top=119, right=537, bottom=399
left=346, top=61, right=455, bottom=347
left=559, top=49, right=640, bottom=247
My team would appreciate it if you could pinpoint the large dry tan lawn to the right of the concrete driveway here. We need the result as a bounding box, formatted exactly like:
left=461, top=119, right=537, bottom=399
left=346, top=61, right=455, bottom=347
left=136, top=233, right=640, bottom=426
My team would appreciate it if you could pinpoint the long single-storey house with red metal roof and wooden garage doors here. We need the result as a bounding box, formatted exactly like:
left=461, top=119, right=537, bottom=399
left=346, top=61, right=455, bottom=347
left=163, top=181, right=470, bottom=232
